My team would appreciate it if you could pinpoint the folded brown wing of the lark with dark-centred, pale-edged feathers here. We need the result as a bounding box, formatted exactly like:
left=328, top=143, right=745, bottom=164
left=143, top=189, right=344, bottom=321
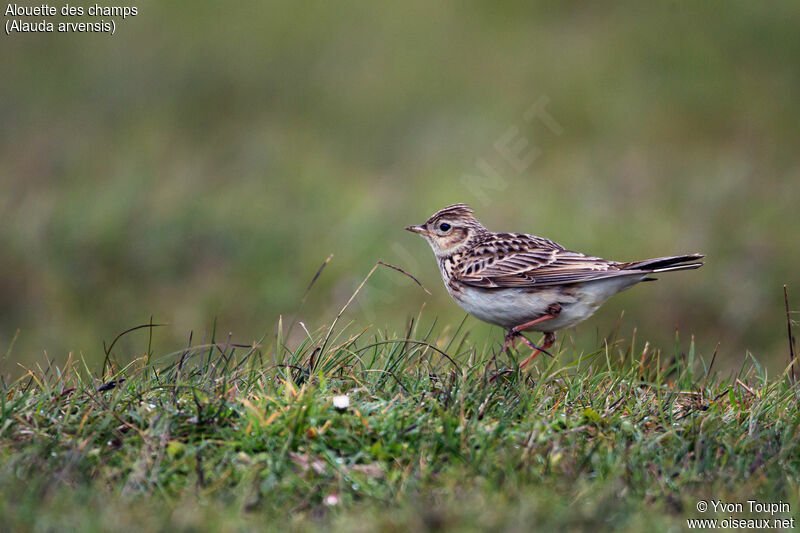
left=453, top=233, right=641, bottom=288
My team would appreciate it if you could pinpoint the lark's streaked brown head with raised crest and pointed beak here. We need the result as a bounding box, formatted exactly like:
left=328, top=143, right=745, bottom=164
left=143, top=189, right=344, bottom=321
left=406, top=204, right=486, bottom=257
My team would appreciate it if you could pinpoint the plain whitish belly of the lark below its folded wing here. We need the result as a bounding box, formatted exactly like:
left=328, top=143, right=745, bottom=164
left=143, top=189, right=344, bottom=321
left=448, top=274, right=646, bottom=332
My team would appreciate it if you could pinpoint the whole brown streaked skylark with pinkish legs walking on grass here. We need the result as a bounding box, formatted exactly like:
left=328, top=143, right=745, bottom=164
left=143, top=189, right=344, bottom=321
left=406, top=204, right=704, bottom=368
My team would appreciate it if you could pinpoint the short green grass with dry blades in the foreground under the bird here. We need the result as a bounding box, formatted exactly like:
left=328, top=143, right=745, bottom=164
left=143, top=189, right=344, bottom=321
left=0, top=306, right=800, bottom=531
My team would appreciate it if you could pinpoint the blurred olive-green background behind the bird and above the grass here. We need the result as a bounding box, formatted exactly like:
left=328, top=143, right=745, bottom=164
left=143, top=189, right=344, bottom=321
left=0, top=0, right=800, bottom=373
